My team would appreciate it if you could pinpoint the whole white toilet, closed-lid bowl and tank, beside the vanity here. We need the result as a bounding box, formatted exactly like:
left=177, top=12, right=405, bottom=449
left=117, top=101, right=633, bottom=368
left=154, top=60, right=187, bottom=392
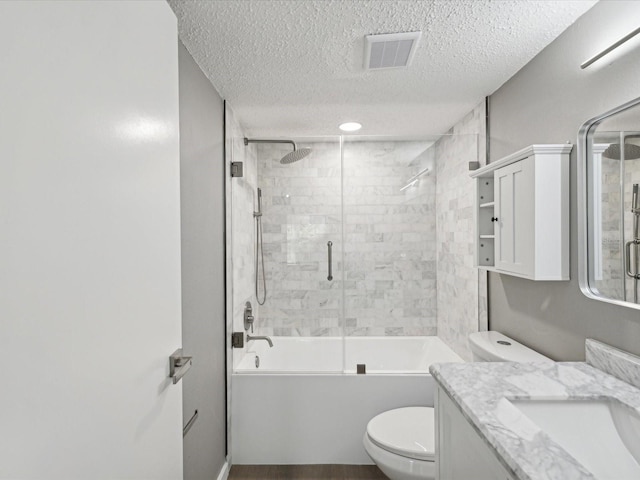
left=362, top=332, right=552, bottom=480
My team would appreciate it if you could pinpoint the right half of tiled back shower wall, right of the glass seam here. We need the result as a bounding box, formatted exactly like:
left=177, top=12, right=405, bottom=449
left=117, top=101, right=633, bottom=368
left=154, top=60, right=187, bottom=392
left=343, top=141, right=437, bottom=336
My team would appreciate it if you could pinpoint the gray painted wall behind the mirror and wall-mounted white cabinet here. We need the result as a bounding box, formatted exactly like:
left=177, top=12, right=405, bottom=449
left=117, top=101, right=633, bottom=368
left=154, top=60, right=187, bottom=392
left=489, top=1, right=640, bottom=360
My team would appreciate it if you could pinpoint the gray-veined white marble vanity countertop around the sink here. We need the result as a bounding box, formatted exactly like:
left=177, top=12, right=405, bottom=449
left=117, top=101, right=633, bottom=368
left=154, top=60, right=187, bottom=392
left=429, top=362, right=640, bottom=480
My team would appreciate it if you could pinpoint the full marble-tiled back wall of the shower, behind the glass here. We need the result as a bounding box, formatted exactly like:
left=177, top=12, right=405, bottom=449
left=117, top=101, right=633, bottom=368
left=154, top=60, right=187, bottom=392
left=258, top=141, right=436, bottom=336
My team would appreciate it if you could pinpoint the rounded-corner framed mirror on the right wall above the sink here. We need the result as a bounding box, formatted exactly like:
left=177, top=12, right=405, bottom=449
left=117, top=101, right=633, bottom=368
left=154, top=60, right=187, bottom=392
left=578, top=98, right=640, bottom=309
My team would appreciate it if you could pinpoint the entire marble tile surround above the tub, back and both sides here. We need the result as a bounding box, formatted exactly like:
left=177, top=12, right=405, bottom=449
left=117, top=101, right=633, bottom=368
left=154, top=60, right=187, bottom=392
left=228, top=108, right=487, bottom=342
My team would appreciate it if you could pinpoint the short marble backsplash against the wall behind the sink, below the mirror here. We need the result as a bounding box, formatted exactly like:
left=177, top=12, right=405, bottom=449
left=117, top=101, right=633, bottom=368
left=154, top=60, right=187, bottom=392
left=585, top=338, right=640, bottom=388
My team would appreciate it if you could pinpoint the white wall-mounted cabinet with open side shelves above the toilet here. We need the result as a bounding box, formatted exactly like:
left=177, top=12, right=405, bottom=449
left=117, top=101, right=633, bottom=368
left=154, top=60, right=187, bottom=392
left=471, top=144, right=573, bottom=280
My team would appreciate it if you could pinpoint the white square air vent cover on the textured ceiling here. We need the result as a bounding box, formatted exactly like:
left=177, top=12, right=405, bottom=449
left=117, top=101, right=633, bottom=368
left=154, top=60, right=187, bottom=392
left=364, top=32, right=422, bottom=70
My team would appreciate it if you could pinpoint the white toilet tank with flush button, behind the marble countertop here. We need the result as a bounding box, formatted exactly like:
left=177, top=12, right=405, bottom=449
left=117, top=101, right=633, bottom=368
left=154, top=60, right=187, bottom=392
left=469, top=332, right=553, bottom=362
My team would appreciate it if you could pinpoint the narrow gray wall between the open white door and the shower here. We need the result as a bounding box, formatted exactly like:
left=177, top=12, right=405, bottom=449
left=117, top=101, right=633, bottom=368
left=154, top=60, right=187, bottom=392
left=179, top=44, right=226, bottom=480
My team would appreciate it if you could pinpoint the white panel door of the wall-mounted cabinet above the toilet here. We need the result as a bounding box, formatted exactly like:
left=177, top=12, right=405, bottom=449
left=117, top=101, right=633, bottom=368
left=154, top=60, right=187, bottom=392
left=494, top=157, right=535, bottom=277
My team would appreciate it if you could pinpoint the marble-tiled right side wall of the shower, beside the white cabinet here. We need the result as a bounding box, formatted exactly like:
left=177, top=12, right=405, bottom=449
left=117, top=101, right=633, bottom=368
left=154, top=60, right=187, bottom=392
left=435, top=103, right=487, bottom=360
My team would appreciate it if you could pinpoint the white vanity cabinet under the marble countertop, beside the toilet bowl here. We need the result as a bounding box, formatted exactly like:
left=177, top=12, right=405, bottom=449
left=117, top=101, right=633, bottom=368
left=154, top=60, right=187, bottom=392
left=435, top=387, right=515, bottom=480
